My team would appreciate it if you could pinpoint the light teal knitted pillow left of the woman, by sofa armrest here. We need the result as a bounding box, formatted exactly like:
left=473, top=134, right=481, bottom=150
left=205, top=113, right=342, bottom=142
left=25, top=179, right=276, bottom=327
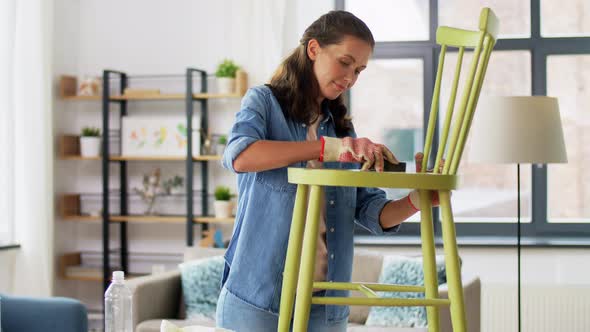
left=179, top=256, right=224, bottom=319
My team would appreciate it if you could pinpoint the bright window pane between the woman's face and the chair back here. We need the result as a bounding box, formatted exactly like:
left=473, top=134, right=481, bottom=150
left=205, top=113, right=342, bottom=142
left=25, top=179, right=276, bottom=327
left=350, top=59, right=424, bottom=221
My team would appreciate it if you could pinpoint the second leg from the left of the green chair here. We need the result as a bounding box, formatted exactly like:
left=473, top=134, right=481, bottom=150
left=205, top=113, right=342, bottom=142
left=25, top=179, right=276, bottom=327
left=293, top=186, right=322, bottom=332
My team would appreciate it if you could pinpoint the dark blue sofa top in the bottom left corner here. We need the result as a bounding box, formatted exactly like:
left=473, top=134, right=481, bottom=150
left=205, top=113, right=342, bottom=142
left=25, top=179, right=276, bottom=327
left=0, top=294, right=88, bottom=332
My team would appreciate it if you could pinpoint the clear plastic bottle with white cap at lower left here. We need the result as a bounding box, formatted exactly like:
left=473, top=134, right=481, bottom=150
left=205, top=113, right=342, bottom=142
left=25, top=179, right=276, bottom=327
left=104, top=271, right=133, bottom=332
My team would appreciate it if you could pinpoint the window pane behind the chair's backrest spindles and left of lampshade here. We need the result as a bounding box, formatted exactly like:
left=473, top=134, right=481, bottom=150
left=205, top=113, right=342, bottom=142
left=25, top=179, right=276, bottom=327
left=439, top=51, right=532, bottom=223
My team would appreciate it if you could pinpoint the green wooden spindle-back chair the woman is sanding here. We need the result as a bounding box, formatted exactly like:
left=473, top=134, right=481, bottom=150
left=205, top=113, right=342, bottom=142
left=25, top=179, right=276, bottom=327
left=278, top=8, right=498, bottom=332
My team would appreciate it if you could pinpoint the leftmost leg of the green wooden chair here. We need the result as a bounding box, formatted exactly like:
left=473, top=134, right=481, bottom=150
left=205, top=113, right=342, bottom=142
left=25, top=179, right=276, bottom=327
left=278, top=184, right=308, bottom=332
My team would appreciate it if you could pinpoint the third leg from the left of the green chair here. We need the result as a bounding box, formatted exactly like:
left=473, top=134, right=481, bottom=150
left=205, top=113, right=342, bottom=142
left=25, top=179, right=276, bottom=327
left=420, top=190, right=440, bottom=332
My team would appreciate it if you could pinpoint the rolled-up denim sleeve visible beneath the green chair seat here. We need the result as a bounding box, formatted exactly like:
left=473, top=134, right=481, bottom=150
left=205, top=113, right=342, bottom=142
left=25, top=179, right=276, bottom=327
left=355, top=187, right=400, bottom=235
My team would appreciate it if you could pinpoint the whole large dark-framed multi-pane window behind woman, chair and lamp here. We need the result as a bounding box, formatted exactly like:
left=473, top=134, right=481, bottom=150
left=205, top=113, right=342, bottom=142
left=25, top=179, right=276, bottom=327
left=336, top=0, right=590, bottom=237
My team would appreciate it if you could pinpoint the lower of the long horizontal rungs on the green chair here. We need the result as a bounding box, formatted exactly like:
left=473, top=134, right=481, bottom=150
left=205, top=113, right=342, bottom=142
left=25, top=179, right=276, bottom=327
left=311, top=296, right=451, bottom=307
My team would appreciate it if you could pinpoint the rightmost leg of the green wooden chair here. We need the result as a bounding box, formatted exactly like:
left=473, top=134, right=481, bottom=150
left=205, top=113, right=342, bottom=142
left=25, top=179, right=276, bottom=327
left=439, top=191, right=467, bottom=332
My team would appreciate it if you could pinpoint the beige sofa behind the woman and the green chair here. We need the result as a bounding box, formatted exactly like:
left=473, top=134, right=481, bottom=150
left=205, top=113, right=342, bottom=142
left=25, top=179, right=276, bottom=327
left=128, top=247, right=481, bottom=332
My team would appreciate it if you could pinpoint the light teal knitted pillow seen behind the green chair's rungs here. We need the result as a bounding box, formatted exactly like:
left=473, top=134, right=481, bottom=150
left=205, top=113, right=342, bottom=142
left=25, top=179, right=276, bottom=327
left=365, top=256, right=447, bottom=327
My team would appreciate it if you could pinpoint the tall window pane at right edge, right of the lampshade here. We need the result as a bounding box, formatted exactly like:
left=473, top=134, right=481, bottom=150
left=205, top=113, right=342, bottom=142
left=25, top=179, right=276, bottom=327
left=547, top=55, right=590, bottom=223
